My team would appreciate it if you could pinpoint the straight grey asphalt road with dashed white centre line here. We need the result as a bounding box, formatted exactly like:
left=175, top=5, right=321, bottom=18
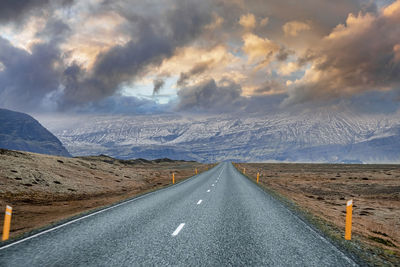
left=0, top=162, right=356, bottom=266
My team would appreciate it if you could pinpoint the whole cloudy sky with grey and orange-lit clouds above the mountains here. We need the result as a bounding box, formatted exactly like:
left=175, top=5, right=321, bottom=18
left=0, top=0, right=400, bottom=114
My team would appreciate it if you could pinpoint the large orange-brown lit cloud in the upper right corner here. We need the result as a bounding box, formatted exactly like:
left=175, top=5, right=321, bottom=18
left=286, top=1, right=400, bottom=103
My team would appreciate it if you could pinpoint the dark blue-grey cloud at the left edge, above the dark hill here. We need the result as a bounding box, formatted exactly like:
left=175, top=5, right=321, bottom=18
left=0, top=37, right=62, bottom=110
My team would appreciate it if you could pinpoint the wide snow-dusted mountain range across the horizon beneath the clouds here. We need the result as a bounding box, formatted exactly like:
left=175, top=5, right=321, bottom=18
left=41, top=111, right=400, bottom=163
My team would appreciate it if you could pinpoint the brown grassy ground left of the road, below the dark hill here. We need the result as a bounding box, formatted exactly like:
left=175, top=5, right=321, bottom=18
left=0, top=149, right=211, bottom=241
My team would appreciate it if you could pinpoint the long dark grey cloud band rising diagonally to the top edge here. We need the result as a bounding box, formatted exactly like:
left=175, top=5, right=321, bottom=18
left=60, top=1, right=211, bottom=108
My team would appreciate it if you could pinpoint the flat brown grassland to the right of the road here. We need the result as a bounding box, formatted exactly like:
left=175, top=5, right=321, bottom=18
left=236, top=163, right=400, bottom=264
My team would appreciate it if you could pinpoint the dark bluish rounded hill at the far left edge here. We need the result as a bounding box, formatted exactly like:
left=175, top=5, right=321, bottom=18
left=0, top=109, right=71, bottom=157
